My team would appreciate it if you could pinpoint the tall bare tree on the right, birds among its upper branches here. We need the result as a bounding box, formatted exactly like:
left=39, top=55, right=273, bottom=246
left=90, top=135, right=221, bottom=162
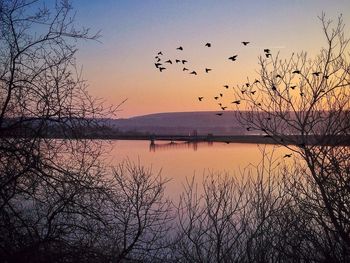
left=232, top=14, right=350, bottom=255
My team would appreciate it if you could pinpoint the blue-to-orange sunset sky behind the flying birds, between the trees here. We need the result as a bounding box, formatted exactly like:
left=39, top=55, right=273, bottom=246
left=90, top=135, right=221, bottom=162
left=68, top=0, right=350, bottom=117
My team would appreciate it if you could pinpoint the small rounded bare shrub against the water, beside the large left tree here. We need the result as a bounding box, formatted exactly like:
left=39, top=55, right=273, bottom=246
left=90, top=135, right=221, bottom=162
left=98, top=160, right=173, bottom=262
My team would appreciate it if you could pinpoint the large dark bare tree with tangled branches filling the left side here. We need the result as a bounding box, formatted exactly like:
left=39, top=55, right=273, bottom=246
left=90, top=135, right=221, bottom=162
left=0, top=0, right=115, bottom=262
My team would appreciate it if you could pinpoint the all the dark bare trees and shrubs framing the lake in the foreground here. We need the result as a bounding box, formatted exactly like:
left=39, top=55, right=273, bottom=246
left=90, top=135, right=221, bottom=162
left=0, top=0, right=350, bottom=262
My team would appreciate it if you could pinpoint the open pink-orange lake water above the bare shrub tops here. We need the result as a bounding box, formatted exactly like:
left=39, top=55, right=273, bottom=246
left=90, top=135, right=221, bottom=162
left=110, top=140, right=289, bottom=199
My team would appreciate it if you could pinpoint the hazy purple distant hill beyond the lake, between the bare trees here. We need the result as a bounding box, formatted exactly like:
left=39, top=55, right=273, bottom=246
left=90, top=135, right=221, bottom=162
left=108, top=111, right=252, bottom=135
